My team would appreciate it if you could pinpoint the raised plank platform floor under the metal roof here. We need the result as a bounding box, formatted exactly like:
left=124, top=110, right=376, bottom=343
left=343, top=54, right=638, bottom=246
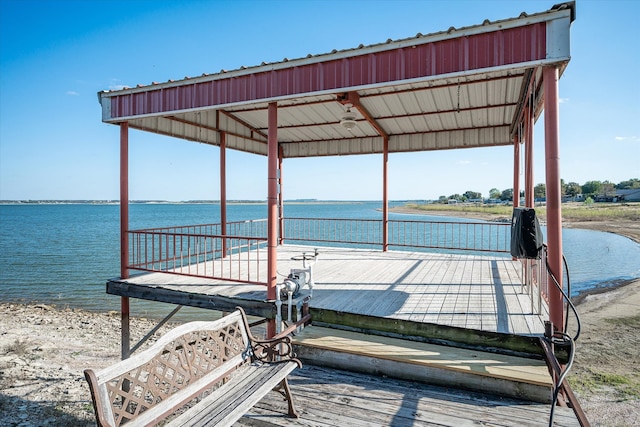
left=107, top=245, right=547, bottom=335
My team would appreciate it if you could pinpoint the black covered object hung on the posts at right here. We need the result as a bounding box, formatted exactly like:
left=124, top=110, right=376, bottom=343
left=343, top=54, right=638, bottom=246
left=511, top=208, right=544, bottom=259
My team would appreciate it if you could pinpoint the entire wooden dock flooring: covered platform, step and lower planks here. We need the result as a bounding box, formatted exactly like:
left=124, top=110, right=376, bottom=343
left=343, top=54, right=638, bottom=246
left=107, top=245, right=578, bottom=426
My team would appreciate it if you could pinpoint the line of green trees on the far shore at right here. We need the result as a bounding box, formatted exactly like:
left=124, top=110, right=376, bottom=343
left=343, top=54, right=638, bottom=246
left=439, top=178, right=640, bottom=202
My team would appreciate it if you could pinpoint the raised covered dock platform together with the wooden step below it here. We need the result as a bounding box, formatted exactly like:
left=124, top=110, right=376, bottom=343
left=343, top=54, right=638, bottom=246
left=107, top=244, right=576, bottom=412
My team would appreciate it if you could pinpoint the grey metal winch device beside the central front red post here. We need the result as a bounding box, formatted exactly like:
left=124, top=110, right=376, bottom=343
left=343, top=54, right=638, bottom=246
left=276, top=248, right=320, bottom=332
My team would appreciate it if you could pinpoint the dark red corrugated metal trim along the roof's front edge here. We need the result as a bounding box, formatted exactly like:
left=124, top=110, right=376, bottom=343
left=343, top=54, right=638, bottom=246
left=108, top=22, right=546, bottom=120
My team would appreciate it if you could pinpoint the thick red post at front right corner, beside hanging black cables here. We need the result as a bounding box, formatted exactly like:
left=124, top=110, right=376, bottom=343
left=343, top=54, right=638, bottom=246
left=542, top=66, right=564, bottom=331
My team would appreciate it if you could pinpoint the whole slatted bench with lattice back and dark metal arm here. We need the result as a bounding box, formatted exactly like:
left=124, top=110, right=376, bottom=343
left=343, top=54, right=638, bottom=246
left=84, top=308, right=302, bottom=427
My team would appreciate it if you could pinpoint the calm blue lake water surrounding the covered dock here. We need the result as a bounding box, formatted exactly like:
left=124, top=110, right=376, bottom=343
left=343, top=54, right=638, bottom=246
left=0, top=202, right=640, bottom=315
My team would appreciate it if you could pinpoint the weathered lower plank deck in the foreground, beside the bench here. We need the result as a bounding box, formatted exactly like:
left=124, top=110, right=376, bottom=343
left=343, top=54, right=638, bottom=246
left=235, top=366, right=579, bottom=427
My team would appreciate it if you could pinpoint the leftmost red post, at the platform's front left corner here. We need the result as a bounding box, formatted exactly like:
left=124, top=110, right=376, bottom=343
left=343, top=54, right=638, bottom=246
left=120, top=122, right=130, bottom=360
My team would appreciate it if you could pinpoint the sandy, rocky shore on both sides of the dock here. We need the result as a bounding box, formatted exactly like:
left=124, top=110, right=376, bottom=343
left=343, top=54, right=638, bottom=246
left=0, top=280, right=640, bottom=427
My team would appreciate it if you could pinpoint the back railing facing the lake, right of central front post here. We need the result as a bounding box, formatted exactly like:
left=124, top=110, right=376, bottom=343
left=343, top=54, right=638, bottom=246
left=282, top=218, right=511, bottom=253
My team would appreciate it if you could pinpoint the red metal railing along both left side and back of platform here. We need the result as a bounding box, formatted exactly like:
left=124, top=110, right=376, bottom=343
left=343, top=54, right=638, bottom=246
left=127, top=218, right=510, bottom=284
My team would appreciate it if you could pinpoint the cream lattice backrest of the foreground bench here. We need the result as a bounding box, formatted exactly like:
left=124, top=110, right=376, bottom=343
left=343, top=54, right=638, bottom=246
left=85, top=310, right=251, bottom=427
